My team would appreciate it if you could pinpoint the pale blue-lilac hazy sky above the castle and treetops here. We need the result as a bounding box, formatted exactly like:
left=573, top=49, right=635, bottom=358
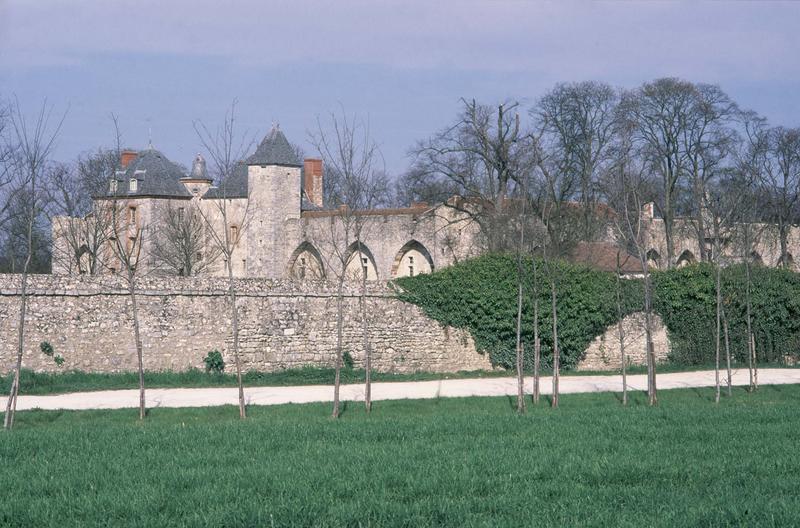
left=0, top=0, right=800, bottom=174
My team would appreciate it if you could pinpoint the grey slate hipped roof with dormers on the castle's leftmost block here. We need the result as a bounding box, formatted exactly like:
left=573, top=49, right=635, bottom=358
left=105, top=148, right=192, bottom=198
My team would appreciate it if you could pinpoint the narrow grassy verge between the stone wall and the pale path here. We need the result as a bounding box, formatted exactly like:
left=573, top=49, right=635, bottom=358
left=0, top=364, right=792, bottom=395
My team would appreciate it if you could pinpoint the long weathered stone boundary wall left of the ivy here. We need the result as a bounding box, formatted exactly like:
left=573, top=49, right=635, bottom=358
left=0, top=275, right=491, bottom=373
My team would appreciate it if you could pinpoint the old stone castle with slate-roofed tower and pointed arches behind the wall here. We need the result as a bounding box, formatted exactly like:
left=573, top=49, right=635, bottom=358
left=53, top=127, right=800, bottom=281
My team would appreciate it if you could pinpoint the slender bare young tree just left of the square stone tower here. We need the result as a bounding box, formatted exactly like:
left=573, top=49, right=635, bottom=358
left=194, top=100, right=254, bottom=419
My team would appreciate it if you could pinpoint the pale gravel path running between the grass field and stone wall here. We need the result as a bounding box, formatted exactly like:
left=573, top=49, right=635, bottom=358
left=17, top=369, right=800, bottom=410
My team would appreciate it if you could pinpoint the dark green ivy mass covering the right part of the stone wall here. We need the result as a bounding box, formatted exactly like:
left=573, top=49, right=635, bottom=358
left=396, top=254, right=800, bottom=368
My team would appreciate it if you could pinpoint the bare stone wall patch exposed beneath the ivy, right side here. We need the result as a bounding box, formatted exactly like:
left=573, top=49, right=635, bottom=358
left=577, top=312, right=669, bottom=370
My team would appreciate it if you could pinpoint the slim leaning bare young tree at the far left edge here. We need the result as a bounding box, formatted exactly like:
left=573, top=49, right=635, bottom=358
left=3, top=101, right=66, bottom=429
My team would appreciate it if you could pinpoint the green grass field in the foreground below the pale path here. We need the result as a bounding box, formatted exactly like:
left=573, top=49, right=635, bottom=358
left=0, top=385, right=800, bottom=527
